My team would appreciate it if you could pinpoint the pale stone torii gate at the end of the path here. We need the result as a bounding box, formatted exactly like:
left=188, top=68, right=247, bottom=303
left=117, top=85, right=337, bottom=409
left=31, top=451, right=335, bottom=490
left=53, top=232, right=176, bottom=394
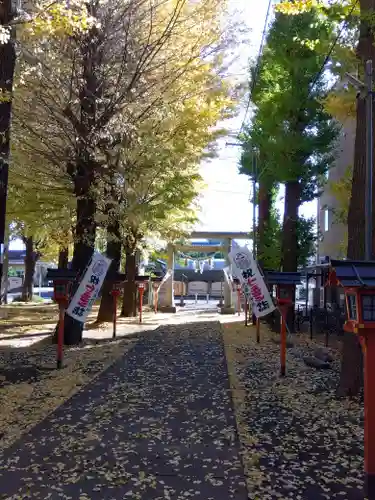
left=159, top=231, right=252, bottom=314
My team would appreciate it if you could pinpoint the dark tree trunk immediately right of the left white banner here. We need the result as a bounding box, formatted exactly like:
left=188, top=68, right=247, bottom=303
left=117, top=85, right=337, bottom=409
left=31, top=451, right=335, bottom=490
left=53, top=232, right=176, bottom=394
left=96, top=222, right=122, bottom=323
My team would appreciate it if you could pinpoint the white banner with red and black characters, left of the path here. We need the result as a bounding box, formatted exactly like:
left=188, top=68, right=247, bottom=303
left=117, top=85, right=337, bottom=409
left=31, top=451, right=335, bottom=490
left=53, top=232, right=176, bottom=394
left=66, top=252, right=111, bottom=323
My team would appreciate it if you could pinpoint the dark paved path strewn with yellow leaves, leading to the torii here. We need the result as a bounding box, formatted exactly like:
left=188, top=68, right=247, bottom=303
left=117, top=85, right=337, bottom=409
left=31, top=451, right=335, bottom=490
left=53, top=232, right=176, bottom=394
left=0, top=323, right=248, bottom=500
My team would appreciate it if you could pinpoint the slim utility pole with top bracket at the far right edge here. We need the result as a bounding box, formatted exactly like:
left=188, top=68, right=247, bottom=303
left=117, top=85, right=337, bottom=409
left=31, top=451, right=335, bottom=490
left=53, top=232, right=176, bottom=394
left=345, top=60, right=374, bottom=260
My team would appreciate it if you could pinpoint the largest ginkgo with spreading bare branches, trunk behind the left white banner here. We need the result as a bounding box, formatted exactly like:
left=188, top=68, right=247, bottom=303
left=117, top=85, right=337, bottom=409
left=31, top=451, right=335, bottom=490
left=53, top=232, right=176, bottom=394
left=11, top=0, right=241, bottom=342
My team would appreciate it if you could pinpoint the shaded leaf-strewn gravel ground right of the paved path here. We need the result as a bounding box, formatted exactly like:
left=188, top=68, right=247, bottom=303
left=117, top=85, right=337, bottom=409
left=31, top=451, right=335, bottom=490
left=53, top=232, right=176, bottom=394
left=223, top=325, right=364, bottom=500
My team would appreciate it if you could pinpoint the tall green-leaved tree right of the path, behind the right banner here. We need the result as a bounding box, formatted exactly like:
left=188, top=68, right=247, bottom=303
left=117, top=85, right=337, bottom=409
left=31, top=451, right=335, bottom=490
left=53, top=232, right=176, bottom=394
left=243, top=10, right=338, bottom=271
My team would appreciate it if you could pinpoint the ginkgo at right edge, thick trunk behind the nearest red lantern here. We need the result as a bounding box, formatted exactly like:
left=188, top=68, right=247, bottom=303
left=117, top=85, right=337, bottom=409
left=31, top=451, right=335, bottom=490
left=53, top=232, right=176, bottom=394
left=278, top=0, right=375, bottom=402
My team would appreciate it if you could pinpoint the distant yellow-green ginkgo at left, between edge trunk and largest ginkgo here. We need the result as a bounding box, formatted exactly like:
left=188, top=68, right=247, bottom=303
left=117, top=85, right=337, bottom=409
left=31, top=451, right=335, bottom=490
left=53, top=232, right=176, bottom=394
left=7, top=135, right=74, bottom=302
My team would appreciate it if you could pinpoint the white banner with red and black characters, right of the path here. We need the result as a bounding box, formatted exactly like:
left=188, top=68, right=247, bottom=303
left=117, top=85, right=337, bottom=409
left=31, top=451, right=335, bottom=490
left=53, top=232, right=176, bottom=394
left=229, top=247, right=276, bottom=318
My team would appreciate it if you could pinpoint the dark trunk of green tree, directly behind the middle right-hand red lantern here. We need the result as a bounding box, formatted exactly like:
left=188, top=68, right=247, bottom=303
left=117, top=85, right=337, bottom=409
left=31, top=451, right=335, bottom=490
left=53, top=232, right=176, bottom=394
left=281, top=181, right=301, bottom=332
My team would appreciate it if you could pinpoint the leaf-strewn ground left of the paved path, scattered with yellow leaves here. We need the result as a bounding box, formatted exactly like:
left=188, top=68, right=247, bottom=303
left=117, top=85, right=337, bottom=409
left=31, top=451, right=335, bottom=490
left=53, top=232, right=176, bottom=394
left=0, top=340, right=134, bottom=449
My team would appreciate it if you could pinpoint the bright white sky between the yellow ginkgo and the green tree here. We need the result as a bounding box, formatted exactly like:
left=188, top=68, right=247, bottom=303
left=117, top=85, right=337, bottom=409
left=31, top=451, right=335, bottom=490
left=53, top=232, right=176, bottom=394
left=196, top=0, right=316, bottom=232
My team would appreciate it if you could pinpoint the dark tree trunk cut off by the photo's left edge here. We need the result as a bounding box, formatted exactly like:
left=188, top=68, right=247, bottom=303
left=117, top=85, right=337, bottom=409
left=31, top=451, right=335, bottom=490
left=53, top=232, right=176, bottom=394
left=0, top=0, right=18, bottom=300
